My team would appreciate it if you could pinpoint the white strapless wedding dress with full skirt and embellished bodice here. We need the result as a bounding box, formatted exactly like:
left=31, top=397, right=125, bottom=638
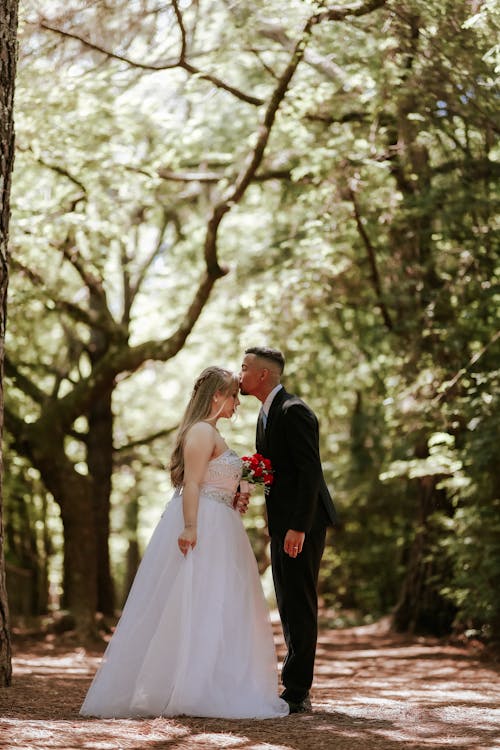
left=80, top=450, right=288, bottom=719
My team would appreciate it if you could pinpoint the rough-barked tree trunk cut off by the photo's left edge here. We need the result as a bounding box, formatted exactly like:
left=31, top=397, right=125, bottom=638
left=0, top=0, right=18, bottom=687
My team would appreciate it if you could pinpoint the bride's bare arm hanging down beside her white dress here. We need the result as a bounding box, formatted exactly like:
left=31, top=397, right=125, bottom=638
left=178, top=422, right=215, bottom=555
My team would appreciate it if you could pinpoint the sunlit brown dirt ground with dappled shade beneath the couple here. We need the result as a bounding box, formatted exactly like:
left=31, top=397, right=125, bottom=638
left=0, top=622, right=500, bottom=750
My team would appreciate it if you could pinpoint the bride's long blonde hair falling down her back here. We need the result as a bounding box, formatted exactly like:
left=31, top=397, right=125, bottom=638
left=169, top=367, right=238, bottom=487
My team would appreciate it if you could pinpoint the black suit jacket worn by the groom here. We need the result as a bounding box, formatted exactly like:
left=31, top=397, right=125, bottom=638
left=257, top=388, right=337, bottom=535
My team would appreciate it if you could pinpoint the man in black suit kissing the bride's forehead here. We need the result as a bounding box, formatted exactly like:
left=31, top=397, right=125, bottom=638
left=240, top=347, right=336, bottom=713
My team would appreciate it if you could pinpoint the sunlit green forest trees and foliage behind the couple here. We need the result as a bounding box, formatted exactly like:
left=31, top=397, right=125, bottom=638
left=4, top=0, right=500, bottom=637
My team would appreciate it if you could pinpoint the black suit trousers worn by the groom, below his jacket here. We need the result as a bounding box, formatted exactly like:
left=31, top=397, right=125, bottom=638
left=271, top=522, right=326, bottom=702
